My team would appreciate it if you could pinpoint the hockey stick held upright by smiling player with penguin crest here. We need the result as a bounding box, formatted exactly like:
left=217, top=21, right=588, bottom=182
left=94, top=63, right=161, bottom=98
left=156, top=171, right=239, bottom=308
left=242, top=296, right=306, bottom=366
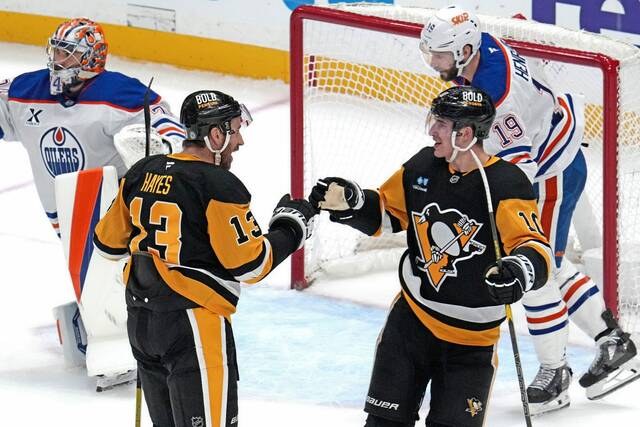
left=469, top=150, right=533, bottom=427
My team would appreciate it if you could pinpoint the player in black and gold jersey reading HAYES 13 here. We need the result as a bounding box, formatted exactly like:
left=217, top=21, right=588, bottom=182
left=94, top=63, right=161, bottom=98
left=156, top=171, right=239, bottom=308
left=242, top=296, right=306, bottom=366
left=94, top=90, right=316, bottom=427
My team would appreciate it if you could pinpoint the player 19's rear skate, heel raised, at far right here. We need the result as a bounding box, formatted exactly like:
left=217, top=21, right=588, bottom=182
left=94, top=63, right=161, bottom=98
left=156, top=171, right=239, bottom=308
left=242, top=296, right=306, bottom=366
left=580, top=310, right=640, bottom=400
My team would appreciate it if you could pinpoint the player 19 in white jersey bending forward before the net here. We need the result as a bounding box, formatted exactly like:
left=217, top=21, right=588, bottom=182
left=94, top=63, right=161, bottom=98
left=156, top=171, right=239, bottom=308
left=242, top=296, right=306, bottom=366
left=420, top=6, right=637, bottom=413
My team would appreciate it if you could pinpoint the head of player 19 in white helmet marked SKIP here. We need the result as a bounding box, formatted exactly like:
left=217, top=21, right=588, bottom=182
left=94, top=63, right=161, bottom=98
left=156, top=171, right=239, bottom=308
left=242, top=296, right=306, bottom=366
left=420, top=6, right=481, bottom=81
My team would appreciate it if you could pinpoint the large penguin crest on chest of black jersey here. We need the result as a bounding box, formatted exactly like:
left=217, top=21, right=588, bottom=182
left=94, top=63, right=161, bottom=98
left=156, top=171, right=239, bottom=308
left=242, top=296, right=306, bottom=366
left=411, top=203, right=486, bottom=292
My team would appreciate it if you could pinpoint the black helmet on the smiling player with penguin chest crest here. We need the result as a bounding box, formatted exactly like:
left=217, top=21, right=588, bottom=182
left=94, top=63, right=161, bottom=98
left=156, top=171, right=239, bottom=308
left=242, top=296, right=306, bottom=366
left=431, top=86, right=496, bottom=141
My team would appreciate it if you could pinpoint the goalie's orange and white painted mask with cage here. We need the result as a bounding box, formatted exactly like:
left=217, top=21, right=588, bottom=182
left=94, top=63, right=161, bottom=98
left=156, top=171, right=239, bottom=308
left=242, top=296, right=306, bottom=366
left=47, top=18, right=108, bottom=95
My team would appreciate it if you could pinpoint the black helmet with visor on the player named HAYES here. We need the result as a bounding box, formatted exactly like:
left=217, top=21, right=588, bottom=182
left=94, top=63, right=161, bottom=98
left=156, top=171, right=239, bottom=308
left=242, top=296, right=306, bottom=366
left=180, top=90, right=252, bottom=140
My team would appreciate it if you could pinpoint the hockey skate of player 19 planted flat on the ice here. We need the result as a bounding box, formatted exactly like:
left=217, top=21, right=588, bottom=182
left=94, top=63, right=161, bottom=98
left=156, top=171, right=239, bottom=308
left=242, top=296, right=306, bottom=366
left=527, top=364, right=573, bottom=415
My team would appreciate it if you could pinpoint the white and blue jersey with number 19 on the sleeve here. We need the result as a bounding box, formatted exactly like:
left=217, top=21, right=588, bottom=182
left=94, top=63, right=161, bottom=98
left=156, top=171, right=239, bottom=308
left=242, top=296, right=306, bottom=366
left=458, top=33, right=584, bottom=182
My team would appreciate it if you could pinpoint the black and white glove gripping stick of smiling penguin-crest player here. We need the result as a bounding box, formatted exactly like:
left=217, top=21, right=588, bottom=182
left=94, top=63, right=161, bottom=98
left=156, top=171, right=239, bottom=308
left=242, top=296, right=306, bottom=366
left=484, top=255, right=535, bottom=304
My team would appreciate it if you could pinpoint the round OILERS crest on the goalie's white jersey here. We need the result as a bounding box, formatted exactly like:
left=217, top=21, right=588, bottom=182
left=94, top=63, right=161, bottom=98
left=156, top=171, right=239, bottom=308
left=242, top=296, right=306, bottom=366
left=40, top=127, right=85, bottom=177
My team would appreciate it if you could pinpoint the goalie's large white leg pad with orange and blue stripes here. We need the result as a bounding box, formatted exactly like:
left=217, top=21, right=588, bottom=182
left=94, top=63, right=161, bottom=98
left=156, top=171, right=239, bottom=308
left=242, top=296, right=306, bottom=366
left=56, top=166, right=136, bottom=376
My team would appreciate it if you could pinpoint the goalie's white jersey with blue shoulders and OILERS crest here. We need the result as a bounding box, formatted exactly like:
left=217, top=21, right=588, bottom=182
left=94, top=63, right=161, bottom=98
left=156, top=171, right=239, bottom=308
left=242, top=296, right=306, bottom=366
left=0, top=69, right=185, bottom=236
